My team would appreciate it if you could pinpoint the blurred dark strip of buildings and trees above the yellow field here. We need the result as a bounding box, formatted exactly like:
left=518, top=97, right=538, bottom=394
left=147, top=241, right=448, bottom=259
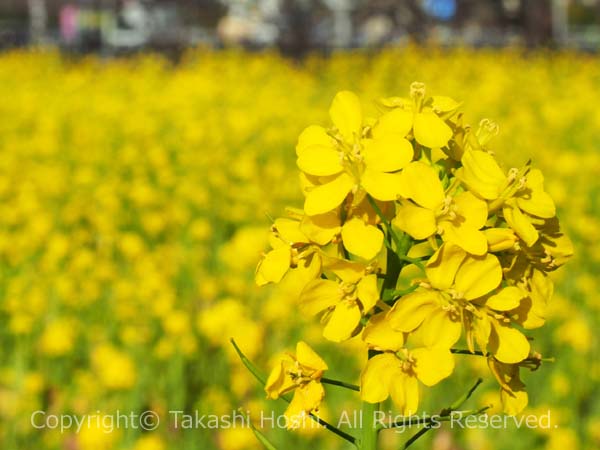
left=0, top=0, right=600, bottom=55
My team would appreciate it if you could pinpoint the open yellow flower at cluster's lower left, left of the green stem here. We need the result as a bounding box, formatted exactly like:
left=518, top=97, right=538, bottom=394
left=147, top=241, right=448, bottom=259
left=300, top=260, right=379, bottom=342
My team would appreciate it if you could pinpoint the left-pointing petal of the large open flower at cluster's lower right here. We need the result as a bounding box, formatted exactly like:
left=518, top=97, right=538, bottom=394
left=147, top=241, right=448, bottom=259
left=388, top=289, right=438, bottom=332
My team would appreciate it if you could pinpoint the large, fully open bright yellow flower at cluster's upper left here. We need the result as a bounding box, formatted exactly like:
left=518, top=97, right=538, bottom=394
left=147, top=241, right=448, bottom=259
left=296, top=91, right=414, bottom=216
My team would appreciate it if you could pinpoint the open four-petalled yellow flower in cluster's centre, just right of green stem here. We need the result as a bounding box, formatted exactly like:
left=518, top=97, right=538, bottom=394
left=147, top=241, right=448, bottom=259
left=393, top=161, right=488, bottom=255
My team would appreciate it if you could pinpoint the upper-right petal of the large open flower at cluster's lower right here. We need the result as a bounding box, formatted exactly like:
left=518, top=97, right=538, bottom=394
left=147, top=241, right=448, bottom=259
left=454, top=253, right=502, bottom=300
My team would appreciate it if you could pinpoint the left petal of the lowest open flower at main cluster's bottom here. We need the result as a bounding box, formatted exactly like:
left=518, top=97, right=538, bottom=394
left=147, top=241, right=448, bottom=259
left=360, top=353, right=399, bottom=403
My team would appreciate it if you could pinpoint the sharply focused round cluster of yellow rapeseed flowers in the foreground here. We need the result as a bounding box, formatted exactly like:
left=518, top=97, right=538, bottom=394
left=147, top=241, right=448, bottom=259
left=256, top=82, right=572, bottom=422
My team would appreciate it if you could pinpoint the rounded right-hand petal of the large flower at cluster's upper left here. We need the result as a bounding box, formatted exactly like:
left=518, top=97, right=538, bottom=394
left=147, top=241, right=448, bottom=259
left=362, top=134, right=414, bottom=172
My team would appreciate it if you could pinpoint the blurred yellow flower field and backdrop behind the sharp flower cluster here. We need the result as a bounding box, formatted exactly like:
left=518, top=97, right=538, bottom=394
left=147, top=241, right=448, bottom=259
left=0, top=0, right=600, bottom=450
